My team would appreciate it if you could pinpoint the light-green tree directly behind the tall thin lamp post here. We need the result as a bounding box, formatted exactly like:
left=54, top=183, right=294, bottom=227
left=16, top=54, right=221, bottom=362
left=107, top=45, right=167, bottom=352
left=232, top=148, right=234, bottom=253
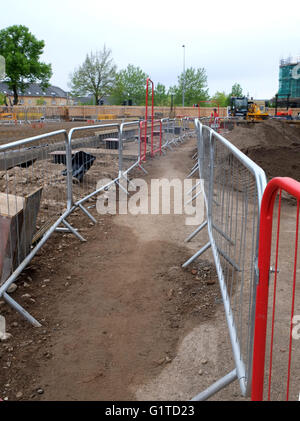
left=170, top=67, right=209, bottom=107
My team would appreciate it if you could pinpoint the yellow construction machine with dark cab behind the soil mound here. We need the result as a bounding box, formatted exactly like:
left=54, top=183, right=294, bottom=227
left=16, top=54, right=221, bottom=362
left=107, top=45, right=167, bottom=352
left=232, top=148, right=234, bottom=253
left=230, top=97, right=269, bottom=121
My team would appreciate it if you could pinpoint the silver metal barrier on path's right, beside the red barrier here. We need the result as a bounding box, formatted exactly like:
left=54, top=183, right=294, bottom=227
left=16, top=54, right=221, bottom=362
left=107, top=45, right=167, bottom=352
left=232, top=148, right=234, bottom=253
left=183, top=119, right=266, bottom=400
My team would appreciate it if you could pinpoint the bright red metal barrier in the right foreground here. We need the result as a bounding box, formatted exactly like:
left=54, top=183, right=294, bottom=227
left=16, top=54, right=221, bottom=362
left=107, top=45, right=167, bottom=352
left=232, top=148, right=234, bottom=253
left=251, top=177, right=300, bottom=401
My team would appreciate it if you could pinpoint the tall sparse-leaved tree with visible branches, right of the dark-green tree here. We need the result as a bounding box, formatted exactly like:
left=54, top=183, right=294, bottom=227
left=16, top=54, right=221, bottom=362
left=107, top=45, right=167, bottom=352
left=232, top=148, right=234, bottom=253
left=69, top=45, right=117, bottom=104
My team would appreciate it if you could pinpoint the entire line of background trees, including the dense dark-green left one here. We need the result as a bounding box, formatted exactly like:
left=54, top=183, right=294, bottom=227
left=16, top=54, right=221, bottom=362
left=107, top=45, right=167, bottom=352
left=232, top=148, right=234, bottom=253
left=0, top=25, right=243, bottom=107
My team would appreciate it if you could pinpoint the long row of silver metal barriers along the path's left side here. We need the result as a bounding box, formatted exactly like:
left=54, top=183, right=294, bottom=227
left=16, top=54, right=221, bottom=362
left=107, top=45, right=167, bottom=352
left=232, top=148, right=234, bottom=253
left=0, top=119, right=192, bottom=326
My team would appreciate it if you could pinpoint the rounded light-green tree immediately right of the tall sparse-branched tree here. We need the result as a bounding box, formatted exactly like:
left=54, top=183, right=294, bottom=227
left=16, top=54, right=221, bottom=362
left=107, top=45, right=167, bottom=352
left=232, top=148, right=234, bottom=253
left=112, top=64, right=151, bottom=105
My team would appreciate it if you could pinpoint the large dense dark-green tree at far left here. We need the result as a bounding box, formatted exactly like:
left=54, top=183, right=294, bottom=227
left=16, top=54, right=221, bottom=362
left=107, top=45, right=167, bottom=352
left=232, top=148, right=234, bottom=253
left=0, top=25, right=52, bottom=105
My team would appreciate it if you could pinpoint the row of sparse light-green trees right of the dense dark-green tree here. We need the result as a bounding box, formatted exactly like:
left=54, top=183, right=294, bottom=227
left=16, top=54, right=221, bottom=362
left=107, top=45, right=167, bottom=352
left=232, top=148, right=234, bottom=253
left=69, top=45, right=243, bottom=107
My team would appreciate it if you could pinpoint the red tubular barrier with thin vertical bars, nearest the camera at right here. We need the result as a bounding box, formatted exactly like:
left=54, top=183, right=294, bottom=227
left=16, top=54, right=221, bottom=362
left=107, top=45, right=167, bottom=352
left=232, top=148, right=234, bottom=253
left=252, top=177, right=300, bottom=400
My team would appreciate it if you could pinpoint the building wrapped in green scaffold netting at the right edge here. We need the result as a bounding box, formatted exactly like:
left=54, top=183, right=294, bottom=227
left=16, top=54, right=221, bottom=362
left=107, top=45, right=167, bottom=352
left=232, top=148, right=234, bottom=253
left=277, top=57, right=300, bottom=108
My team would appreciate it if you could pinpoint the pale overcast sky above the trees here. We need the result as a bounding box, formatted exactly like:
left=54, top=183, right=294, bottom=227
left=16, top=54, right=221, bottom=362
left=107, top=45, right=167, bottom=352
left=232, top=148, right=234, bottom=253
left=0, top=0, right=300, bottom=99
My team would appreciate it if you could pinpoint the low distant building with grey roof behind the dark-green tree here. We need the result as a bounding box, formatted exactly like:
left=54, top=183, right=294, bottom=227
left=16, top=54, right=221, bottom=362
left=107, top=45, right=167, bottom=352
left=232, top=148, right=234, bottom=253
left=0, top=82, right=73, bottom=106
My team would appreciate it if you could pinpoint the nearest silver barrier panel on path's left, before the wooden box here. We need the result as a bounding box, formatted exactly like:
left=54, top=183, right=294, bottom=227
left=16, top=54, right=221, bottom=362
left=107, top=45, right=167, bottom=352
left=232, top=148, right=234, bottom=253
left=0, top=130, right=76, bottom=326
